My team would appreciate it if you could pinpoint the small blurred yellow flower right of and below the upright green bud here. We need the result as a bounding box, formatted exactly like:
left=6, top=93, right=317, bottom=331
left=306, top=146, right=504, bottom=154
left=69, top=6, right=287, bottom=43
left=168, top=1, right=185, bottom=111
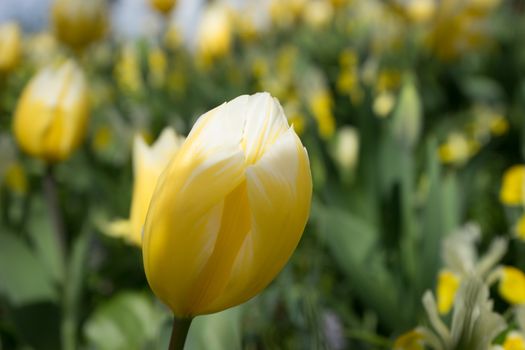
left=439, top=132, right=480, bottom=165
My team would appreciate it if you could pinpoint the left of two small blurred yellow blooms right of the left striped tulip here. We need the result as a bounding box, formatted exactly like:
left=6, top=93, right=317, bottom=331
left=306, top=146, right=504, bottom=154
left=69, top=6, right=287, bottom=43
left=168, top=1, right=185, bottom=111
left=114, top=43, right=144, bottom=94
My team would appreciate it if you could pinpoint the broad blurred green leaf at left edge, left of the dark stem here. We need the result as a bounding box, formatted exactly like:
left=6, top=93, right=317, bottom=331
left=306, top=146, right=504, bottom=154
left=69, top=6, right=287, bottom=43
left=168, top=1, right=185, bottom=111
left=0, top=232, right=58, bottom=306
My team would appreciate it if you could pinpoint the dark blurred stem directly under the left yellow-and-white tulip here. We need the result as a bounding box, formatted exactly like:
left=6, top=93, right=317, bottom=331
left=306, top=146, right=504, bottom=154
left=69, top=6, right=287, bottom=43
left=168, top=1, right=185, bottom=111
left=43, top=165, right=67, bottom=266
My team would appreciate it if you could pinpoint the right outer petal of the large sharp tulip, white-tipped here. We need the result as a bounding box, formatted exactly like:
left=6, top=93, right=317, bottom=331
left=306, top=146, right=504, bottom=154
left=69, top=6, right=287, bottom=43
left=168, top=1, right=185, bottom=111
left=205, top=129, right=312, bottom=313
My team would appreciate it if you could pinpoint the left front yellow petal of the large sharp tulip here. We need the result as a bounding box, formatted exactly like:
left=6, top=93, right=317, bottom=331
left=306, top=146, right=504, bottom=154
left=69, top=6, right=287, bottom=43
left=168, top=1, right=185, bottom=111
left=143, top=144, right=245, bottom=316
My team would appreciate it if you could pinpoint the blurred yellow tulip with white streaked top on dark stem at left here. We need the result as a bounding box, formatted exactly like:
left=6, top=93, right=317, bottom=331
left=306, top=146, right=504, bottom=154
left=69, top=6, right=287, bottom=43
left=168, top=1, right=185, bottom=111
left=13, top=61, right=89, bottom=162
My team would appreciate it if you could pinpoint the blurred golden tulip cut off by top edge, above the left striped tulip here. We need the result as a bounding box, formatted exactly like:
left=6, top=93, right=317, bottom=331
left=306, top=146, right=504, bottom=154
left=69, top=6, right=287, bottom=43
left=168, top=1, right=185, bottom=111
left=52, top=0, right=107, bottom=50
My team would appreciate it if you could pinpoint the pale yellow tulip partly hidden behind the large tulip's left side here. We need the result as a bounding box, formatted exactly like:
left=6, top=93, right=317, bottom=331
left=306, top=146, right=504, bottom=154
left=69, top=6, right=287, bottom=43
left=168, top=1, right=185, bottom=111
left=106, top=128, right=184, bottom=246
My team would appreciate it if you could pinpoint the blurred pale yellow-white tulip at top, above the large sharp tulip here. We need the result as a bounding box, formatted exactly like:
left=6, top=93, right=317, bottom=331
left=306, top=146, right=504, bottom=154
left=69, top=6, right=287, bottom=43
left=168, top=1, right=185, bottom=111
left=197, top=4, right=233, bottom=63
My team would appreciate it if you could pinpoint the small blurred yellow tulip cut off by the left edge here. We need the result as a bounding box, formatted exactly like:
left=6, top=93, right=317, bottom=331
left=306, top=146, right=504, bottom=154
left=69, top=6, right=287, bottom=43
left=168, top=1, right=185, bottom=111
left=0, top=22, right=22, bottom=72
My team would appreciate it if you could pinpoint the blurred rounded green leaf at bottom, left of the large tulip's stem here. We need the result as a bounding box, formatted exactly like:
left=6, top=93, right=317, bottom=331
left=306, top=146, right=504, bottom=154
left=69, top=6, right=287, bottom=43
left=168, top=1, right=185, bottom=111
left=84, top=292, right=168, bottom=350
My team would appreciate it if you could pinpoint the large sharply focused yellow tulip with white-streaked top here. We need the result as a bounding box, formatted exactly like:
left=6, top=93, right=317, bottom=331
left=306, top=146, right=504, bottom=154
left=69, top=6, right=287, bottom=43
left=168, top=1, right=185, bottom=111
left=142, top=93, right=312, bottom=317
